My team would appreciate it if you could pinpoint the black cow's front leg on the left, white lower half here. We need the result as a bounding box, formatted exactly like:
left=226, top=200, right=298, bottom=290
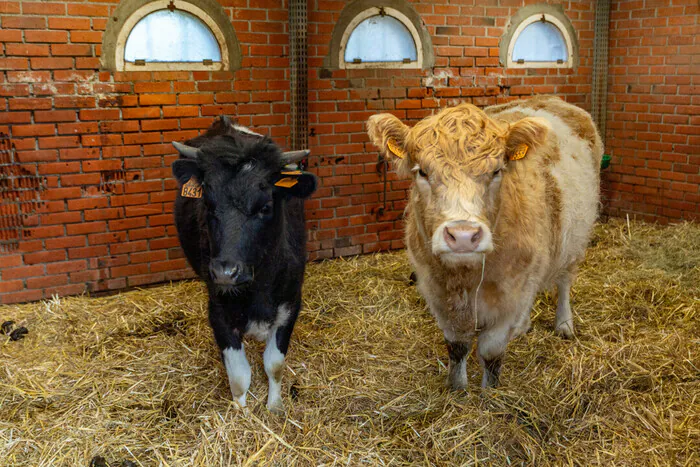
left=209, top=300, right=251, bottom=407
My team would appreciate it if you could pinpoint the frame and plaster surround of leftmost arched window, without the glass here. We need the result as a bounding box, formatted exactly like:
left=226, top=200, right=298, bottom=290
left=100, top=0, right=241, bottom=71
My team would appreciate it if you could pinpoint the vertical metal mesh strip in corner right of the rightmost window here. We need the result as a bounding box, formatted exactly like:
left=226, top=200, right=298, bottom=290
left=591, top=0, right=610, bottom=141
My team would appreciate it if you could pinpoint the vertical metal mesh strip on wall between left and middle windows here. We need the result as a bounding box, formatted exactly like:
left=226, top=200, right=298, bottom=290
left=289, top=0, right=309, bottom=149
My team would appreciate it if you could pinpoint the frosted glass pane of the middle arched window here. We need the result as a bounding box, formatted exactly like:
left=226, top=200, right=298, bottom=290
left=345, top=15, right=418, bottom=63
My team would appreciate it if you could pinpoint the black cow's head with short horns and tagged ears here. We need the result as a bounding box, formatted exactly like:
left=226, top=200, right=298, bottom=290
left=172, top=128, right=316, bottom=292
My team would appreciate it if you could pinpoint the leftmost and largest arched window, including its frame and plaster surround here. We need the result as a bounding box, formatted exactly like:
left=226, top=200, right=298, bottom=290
left=102, top=0, right=241, bottom=71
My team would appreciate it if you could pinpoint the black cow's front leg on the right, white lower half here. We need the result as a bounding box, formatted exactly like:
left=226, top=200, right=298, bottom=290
left=263, top=304, right=300, bottom=413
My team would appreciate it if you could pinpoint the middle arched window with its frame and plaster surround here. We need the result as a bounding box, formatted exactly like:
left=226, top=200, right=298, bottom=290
left=324, top=0, right=433, bottom=69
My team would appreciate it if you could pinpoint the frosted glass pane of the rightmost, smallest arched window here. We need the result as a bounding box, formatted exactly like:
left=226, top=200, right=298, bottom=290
left=513, top=21, right=569, bottom=62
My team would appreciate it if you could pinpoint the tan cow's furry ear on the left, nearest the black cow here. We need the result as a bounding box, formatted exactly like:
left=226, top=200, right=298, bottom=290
left=367, top=114, right=413, bottom=176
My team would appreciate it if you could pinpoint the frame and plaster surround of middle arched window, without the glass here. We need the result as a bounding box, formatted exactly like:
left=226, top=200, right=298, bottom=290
left=324, top=0, right=435, bottom=69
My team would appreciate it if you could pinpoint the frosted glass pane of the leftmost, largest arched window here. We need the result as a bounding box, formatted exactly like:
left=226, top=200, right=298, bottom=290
left=124, top=10, right=221, bottom=62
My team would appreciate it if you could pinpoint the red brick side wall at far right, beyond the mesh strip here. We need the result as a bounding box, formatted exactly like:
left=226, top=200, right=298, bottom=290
left=606, top=0, right=700, bottom=223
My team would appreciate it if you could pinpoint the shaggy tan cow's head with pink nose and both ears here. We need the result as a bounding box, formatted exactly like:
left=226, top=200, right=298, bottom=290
left=368, top=104, right=548, bottom=265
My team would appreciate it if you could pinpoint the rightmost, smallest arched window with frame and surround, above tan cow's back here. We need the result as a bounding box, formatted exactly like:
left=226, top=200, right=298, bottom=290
left=501, top=5, right=578, bottom=68
